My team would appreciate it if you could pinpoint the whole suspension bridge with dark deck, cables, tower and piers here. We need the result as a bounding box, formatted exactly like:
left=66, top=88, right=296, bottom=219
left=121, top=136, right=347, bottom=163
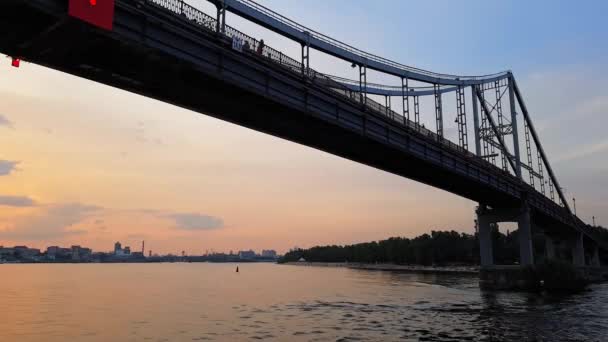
left=0, top=0, right=607, bottom=280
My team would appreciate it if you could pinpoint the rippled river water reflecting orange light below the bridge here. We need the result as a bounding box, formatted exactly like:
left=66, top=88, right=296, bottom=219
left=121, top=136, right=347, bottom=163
left=0, top=263, right=608, bottom=341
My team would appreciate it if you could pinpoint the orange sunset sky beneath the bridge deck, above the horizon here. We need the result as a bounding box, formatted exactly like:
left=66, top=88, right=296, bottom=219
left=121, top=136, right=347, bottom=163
left=0, top=63, right=474, bottom=253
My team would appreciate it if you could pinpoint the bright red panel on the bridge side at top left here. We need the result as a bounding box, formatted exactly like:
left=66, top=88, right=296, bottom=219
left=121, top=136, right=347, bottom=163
left=68, top=0, right=114, bottom=31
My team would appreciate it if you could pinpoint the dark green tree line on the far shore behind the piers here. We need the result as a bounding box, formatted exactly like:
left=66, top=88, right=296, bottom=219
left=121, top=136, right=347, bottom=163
left=279, top=226, right=608, bottom=265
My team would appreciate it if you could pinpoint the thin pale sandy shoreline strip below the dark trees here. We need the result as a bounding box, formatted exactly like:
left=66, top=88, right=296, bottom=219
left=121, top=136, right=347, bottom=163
left=283, top=261, right=479, bottom=275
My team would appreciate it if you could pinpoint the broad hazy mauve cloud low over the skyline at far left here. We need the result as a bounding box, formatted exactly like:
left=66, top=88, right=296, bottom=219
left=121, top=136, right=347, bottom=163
left=0, top=203, right=101, bottom=241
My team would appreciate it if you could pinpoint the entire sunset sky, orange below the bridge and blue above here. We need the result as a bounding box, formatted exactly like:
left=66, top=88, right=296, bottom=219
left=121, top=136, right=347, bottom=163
left=0, top=0, right=608, bottom=254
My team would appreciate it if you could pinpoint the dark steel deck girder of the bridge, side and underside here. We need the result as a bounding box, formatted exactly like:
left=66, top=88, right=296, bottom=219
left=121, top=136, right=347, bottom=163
left=0, top=0, right=584, bottom=243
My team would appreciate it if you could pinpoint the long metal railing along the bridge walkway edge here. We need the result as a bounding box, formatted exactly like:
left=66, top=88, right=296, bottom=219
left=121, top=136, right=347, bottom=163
left=147, top=0, right=473, bottom=156
